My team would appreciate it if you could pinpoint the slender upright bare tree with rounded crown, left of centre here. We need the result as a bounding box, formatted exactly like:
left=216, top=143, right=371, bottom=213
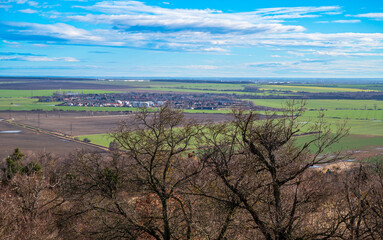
left=112, top=106, right=206, bottom=239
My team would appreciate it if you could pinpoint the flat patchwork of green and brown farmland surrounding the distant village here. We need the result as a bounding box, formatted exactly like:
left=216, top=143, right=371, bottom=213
left=0, top=79, right=383, bottom=156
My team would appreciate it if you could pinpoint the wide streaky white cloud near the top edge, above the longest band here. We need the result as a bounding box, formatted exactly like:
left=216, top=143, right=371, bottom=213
left=68, top=1, right=304, bottom=34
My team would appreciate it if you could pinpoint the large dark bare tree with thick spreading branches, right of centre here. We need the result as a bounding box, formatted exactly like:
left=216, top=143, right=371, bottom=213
left=201, top=101, right=348, bottom=240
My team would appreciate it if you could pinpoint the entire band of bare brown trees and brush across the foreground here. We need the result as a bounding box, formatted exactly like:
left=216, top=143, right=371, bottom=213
left=0, top=102, right=383, bottom=240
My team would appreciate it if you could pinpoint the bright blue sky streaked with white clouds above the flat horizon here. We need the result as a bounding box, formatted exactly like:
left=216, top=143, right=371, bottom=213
left=0, top=0, right=383, bottom=78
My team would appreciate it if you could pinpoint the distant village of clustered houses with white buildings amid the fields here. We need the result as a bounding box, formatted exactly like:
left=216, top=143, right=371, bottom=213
left=38, top=92, right=250, bottom=110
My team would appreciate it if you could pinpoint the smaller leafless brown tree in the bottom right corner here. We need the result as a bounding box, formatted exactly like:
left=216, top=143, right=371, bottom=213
left=332, top=158, right=383, bottom=240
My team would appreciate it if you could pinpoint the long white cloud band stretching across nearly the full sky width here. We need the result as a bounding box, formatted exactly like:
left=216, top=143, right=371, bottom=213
left=5, top=22, right=383, bottom=52
